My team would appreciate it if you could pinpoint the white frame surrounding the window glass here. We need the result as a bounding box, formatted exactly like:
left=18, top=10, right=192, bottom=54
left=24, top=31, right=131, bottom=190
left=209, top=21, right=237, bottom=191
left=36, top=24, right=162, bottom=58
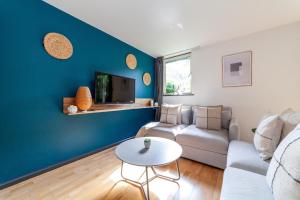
left=163, top=52, right=194, bottom=96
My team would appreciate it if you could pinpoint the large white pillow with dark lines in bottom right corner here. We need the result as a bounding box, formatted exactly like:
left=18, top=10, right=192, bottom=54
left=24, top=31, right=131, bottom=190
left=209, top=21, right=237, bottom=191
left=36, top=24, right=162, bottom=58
left=266, top=124, right=300, bottom=200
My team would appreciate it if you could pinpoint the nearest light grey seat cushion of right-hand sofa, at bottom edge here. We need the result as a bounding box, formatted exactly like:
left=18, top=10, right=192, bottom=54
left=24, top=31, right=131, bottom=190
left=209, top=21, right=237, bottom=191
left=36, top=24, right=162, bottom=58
left=220, top=167, right=273, bottom=200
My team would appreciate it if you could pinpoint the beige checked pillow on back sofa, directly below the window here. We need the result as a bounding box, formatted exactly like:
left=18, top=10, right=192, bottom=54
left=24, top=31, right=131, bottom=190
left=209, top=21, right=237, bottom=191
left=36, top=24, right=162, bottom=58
left=160, top=105, right=181, bottom=125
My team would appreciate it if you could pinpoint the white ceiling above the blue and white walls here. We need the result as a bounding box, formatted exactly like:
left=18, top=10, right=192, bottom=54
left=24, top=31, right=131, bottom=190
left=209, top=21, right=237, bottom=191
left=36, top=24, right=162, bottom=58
left=45, top=0, right=300, bottom=57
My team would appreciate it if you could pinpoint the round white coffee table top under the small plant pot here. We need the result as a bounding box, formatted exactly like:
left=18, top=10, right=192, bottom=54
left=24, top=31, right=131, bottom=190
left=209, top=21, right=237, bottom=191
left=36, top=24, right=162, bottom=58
left=115, top=137, right=182, bottom=166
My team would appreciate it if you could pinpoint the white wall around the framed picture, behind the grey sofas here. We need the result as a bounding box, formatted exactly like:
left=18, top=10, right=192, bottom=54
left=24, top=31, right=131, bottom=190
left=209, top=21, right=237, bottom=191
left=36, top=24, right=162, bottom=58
left=164, top=22, right=300, bottom=141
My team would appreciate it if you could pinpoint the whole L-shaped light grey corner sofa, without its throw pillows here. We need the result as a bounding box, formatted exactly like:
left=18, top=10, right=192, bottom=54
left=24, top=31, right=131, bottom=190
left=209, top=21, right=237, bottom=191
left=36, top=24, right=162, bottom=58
left=138, top=106, right=273, bottom=200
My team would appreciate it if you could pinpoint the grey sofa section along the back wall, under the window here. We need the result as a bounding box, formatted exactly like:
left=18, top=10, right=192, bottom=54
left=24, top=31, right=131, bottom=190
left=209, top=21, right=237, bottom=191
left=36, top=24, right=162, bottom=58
left=138, top=105, right=239, bottom=169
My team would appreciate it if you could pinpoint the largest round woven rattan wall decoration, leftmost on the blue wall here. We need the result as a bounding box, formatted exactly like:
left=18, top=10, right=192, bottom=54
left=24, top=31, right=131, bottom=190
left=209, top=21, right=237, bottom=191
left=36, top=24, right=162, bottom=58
left=44, top=33, right=73, bottom=59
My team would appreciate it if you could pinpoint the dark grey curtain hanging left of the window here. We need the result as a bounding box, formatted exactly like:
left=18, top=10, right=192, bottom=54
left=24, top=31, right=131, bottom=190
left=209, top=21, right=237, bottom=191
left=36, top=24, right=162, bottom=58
left=154, top=57, right=164, bottom=121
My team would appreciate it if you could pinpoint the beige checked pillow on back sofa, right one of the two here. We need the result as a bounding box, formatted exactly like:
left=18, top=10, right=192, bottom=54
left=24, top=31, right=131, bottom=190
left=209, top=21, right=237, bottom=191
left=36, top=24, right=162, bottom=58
left=195, top=106, right=222, bottom=130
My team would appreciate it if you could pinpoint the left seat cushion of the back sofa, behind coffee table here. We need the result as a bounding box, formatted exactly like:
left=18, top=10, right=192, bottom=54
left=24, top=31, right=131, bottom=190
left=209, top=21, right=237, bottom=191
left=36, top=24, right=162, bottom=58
left=145, top=123, right=186, bottom=140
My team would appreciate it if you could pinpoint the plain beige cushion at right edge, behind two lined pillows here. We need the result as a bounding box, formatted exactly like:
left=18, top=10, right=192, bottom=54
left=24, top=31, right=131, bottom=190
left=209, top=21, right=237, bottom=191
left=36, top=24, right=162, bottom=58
left=280, top=108, right=300, bottom=140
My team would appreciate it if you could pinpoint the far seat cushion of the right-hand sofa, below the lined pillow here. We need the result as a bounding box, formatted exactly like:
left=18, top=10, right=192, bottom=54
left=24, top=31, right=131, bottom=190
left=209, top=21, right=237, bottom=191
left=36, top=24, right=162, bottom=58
left=227, top=140, right=270, bottom=175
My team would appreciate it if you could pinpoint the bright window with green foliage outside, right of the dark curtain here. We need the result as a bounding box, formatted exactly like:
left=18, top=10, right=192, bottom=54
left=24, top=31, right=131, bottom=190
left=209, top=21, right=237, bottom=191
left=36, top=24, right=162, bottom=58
left=164, top=53, right=192, bottom=95
